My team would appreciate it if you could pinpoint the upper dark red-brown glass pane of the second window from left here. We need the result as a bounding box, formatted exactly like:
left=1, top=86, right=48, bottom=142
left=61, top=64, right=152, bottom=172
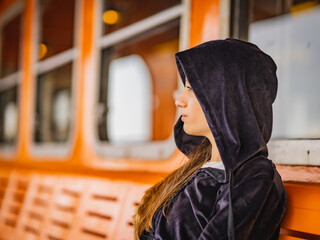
left=39, top=0, right=75, bottom=59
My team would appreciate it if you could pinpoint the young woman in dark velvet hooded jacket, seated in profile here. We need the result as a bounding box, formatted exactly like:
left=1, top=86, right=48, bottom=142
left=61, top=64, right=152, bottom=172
left=135, top=39, right=286, bottom=240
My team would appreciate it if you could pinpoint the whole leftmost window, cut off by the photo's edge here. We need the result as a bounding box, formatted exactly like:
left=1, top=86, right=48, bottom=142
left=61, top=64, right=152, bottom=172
left=0, top=2, right=23, bottom=151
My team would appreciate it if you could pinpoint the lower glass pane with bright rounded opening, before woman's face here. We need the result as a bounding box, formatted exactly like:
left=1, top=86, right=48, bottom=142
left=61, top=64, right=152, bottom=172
left=98, top=19, right=179, bottom=143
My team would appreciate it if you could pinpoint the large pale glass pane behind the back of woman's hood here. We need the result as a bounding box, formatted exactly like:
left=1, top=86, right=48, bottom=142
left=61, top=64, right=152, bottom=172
left=249, top=1, right=320, bottom=139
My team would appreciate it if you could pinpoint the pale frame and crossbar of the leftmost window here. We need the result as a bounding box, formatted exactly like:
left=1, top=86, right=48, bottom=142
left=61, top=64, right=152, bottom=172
left=0, top=0, right=25, bottom=156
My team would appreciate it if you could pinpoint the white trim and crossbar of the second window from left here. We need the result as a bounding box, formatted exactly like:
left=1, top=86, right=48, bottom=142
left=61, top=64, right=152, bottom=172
left=30, top=0, right=83, bottom=158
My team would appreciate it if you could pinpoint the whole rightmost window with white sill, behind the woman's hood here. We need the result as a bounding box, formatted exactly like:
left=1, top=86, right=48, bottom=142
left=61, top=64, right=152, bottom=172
left=249, top=0, right=320, bottom=165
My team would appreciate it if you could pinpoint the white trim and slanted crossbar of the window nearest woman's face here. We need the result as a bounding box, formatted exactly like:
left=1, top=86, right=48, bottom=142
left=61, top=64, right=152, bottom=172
left=89, top=0, right=190, bottom=160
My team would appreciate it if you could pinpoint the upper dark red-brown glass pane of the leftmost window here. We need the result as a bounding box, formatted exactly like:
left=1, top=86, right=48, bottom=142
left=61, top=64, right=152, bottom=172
left=0, top=14, right=21, bottom=78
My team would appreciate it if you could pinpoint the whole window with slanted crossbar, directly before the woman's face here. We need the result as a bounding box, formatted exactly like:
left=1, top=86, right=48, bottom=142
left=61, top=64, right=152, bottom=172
left=96, top=1, right=184, bottom=159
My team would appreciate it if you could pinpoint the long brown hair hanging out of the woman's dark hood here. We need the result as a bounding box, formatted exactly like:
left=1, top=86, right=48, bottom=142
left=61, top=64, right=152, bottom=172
left=134, top=138, right=211, bottom=239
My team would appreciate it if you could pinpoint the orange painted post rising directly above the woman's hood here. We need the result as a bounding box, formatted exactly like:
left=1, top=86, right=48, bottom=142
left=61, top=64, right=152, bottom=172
left=190, top=0, right=220, bottom=47
